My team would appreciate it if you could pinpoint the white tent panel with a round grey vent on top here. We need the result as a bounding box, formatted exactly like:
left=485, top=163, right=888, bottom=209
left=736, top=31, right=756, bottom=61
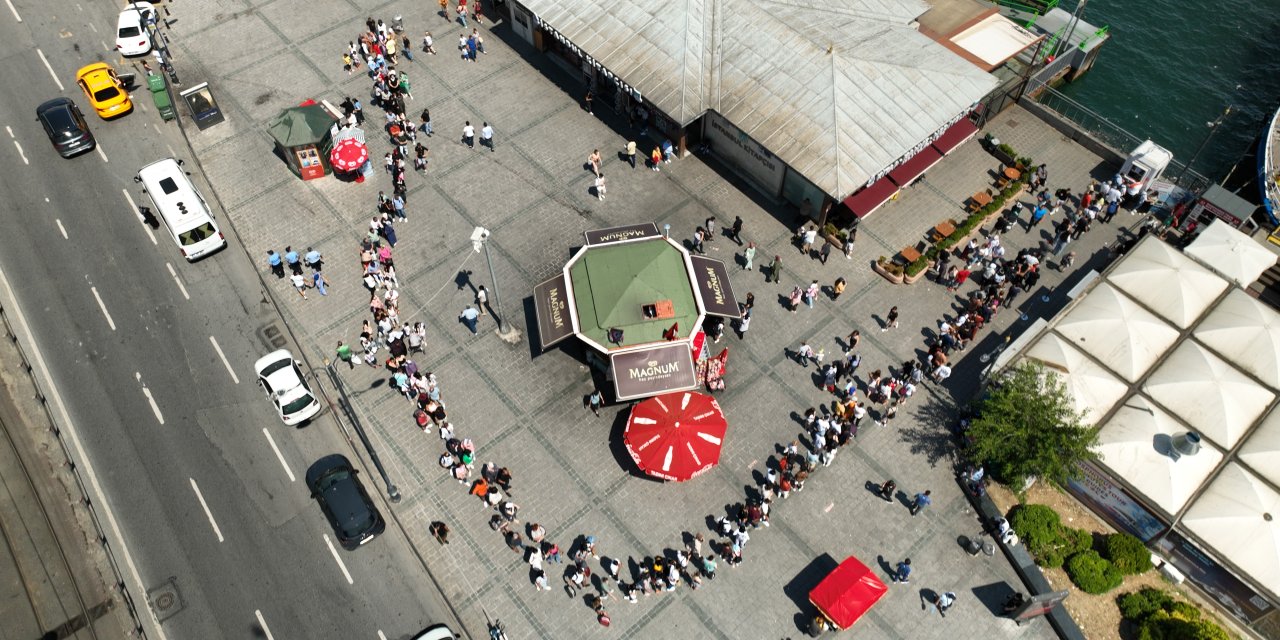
left=1094, top=396, right=1222, bottom=516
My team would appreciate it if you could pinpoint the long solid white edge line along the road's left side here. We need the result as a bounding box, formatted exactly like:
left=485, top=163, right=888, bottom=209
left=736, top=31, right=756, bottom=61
left=0, top=264, right=169, bottom=640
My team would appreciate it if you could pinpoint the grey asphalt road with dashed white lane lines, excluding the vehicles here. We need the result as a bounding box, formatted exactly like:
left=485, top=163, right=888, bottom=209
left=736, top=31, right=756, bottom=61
left=0, top=0, right=447, bottom=637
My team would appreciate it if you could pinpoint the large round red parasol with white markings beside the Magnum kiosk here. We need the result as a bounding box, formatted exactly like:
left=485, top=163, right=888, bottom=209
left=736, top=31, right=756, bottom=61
left=622, top=392, right=728, bottom=483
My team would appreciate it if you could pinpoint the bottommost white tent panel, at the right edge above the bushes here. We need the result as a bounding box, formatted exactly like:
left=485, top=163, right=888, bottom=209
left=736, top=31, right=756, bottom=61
left=1183, top=462, right=1280, bottom=593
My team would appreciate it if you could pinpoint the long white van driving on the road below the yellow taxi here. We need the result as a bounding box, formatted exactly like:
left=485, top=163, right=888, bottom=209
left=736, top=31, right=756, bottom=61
left=134, top=157, right=227, bottom=262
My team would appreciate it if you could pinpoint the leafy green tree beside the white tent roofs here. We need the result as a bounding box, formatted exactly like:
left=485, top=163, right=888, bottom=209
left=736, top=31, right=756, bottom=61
left=968, top=360, right=1098, bottom=486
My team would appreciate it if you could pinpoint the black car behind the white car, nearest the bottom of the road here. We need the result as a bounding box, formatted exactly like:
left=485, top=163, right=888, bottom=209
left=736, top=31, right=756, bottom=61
left=307, top=453, right=387, bottom=549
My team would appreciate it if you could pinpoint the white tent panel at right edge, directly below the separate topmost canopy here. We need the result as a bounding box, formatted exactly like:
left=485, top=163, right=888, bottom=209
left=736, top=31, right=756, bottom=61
left=1194, top=289, right=1280, bottom=388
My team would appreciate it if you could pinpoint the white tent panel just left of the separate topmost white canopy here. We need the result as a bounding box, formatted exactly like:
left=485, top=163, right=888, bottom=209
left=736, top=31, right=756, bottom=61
left=1107, top=232, right=1228, bottom=329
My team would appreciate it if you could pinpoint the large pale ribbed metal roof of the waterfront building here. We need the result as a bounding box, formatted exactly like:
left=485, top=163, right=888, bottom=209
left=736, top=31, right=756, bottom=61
left=521, top=0, right=997, bottom=200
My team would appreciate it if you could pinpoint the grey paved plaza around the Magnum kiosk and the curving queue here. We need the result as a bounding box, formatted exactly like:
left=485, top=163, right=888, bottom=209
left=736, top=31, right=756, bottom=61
left=165, top=0, right=1132, bottom=639
